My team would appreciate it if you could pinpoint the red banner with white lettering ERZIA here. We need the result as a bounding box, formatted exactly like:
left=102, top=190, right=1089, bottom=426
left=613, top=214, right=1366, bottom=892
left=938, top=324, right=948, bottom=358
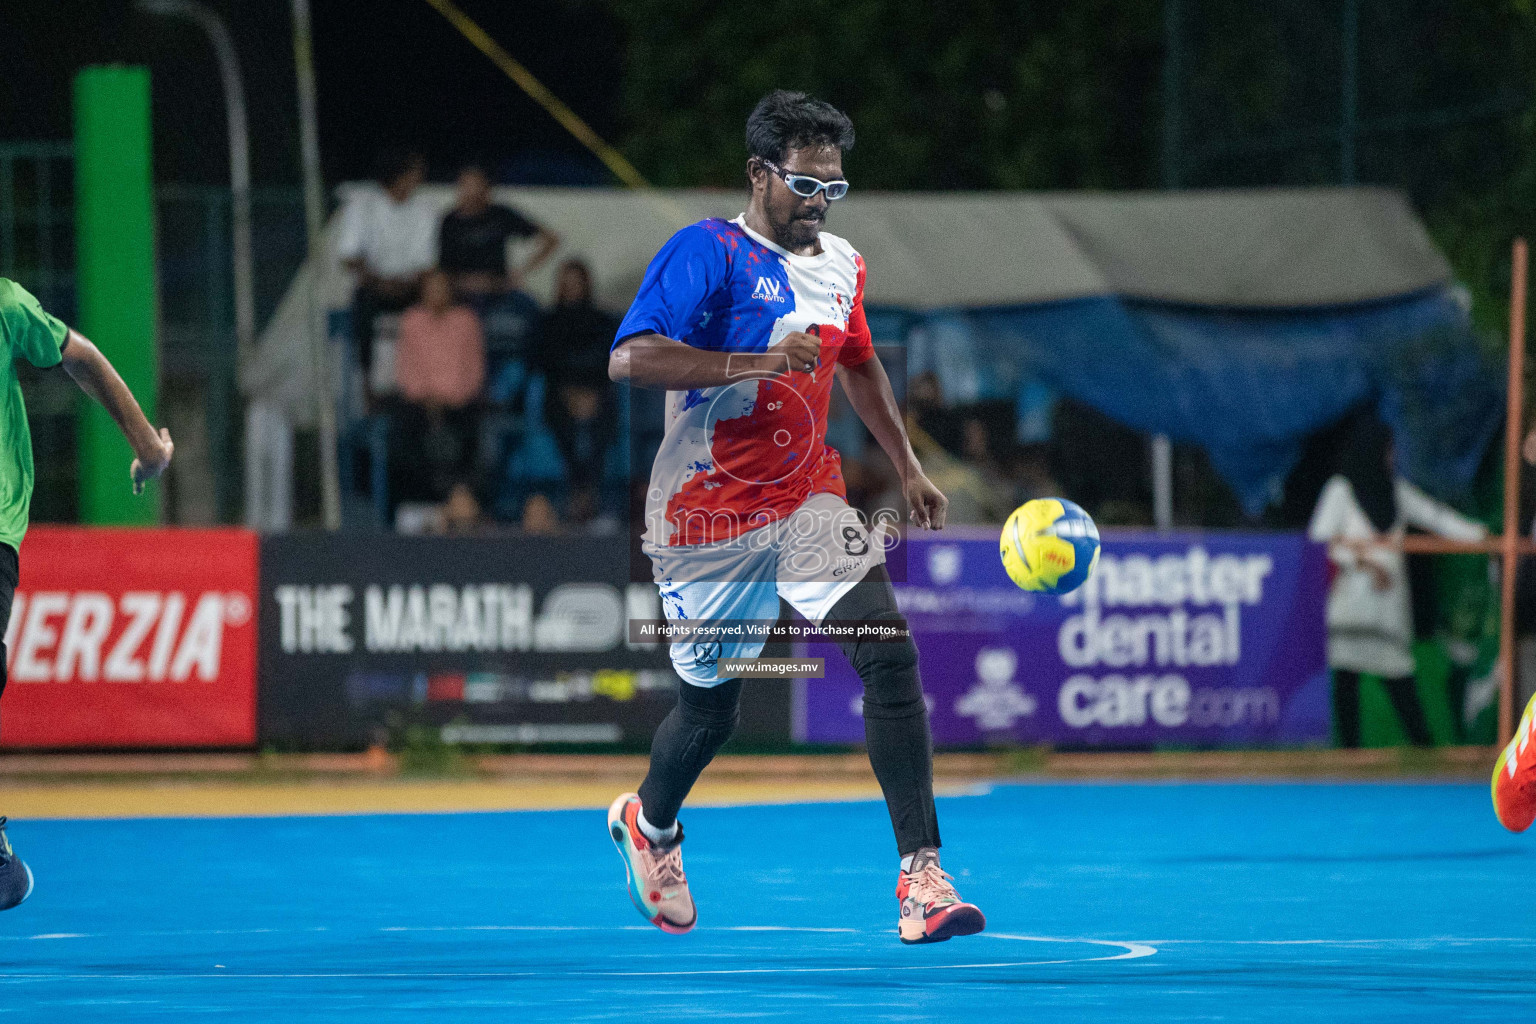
left=0, top=527, right=257, bottom=748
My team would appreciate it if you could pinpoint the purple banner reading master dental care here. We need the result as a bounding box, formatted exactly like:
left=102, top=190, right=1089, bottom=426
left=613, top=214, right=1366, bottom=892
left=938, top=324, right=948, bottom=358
left=796, top=531, right=1330, bottom=748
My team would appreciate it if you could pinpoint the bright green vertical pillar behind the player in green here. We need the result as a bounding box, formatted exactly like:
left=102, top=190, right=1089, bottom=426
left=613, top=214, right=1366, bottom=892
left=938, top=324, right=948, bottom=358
left=75, top=66, right=160, bottom=525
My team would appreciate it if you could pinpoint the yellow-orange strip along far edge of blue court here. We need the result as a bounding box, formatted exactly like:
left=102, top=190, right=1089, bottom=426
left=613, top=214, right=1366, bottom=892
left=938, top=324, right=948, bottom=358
left=0, top=748, right=1498, bottom=820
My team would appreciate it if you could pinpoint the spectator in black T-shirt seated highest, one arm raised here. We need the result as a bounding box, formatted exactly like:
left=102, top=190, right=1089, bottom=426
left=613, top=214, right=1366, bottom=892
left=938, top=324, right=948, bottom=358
left=438, top=164, right=561, bottom=302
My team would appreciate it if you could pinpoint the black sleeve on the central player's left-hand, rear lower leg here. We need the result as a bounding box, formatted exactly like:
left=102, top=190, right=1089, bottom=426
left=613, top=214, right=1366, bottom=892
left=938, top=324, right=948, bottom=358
left=629, top=679, right=742, bottom=829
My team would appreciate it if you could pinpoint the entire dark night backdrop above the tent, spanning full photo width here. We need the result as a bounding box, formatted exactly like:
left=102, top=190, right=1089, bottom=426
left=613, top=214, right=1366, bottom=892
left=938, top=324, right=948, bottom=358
left=0, top=0, right=1536, bottom=328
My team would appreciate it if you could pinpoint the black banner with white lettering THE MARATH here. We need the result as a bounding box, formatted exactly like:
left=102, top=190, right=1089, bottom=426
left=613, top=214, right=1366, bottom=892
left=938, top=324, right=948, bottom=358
left=260, top=534, right=712, bottom=748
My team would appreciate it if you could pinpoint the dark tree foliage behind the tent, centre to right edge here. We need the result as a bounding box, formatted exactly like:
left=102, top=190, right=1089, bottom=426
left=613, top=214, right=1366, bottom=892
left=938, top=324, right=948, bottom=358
left=613, top=0, right=1536, bottom=340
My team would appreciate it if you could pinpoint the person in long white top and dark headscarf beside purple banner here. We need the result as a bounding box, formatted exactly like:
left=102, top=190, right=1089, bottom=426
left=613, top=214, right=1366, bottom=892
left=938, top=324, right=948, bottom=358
left=1307, top=416, right=1487, bottom=746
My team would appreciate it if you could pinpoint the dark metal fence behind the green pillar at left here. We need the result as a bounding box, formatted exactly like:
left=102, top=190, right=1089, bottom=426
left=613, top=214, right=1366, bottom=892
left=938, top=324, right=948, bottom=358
left=0, top=141, right=306, bottom=525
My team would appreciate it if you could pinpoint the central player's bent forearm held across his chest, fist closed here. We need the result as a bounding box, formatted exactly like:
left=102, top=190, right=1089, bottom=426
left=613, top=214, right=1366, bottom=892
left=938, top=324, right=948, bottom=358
left=608, top=332, right=822, bottom=391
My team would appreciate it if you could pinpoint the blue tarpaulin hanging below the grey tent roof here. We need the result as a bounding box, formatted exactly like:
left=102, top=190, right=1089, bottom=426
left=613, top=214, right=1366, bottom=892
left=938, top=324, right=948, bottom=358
left=876, top=287, right=1504, bottom=513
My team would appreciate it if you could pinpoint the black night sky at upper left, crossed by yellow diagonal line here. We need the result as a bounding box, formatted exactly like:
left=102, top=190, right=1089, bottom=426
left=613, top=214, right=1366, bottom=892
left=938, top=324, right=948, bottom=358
left=0, top=0, right=621, bottom=184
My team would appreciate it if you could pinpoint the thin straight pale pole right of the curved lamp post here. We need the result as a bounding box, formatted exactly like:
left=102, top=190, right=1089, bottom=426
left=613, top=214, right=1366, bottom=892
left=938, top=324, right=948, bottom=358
left=293, top=0, right=341, bottom=530
